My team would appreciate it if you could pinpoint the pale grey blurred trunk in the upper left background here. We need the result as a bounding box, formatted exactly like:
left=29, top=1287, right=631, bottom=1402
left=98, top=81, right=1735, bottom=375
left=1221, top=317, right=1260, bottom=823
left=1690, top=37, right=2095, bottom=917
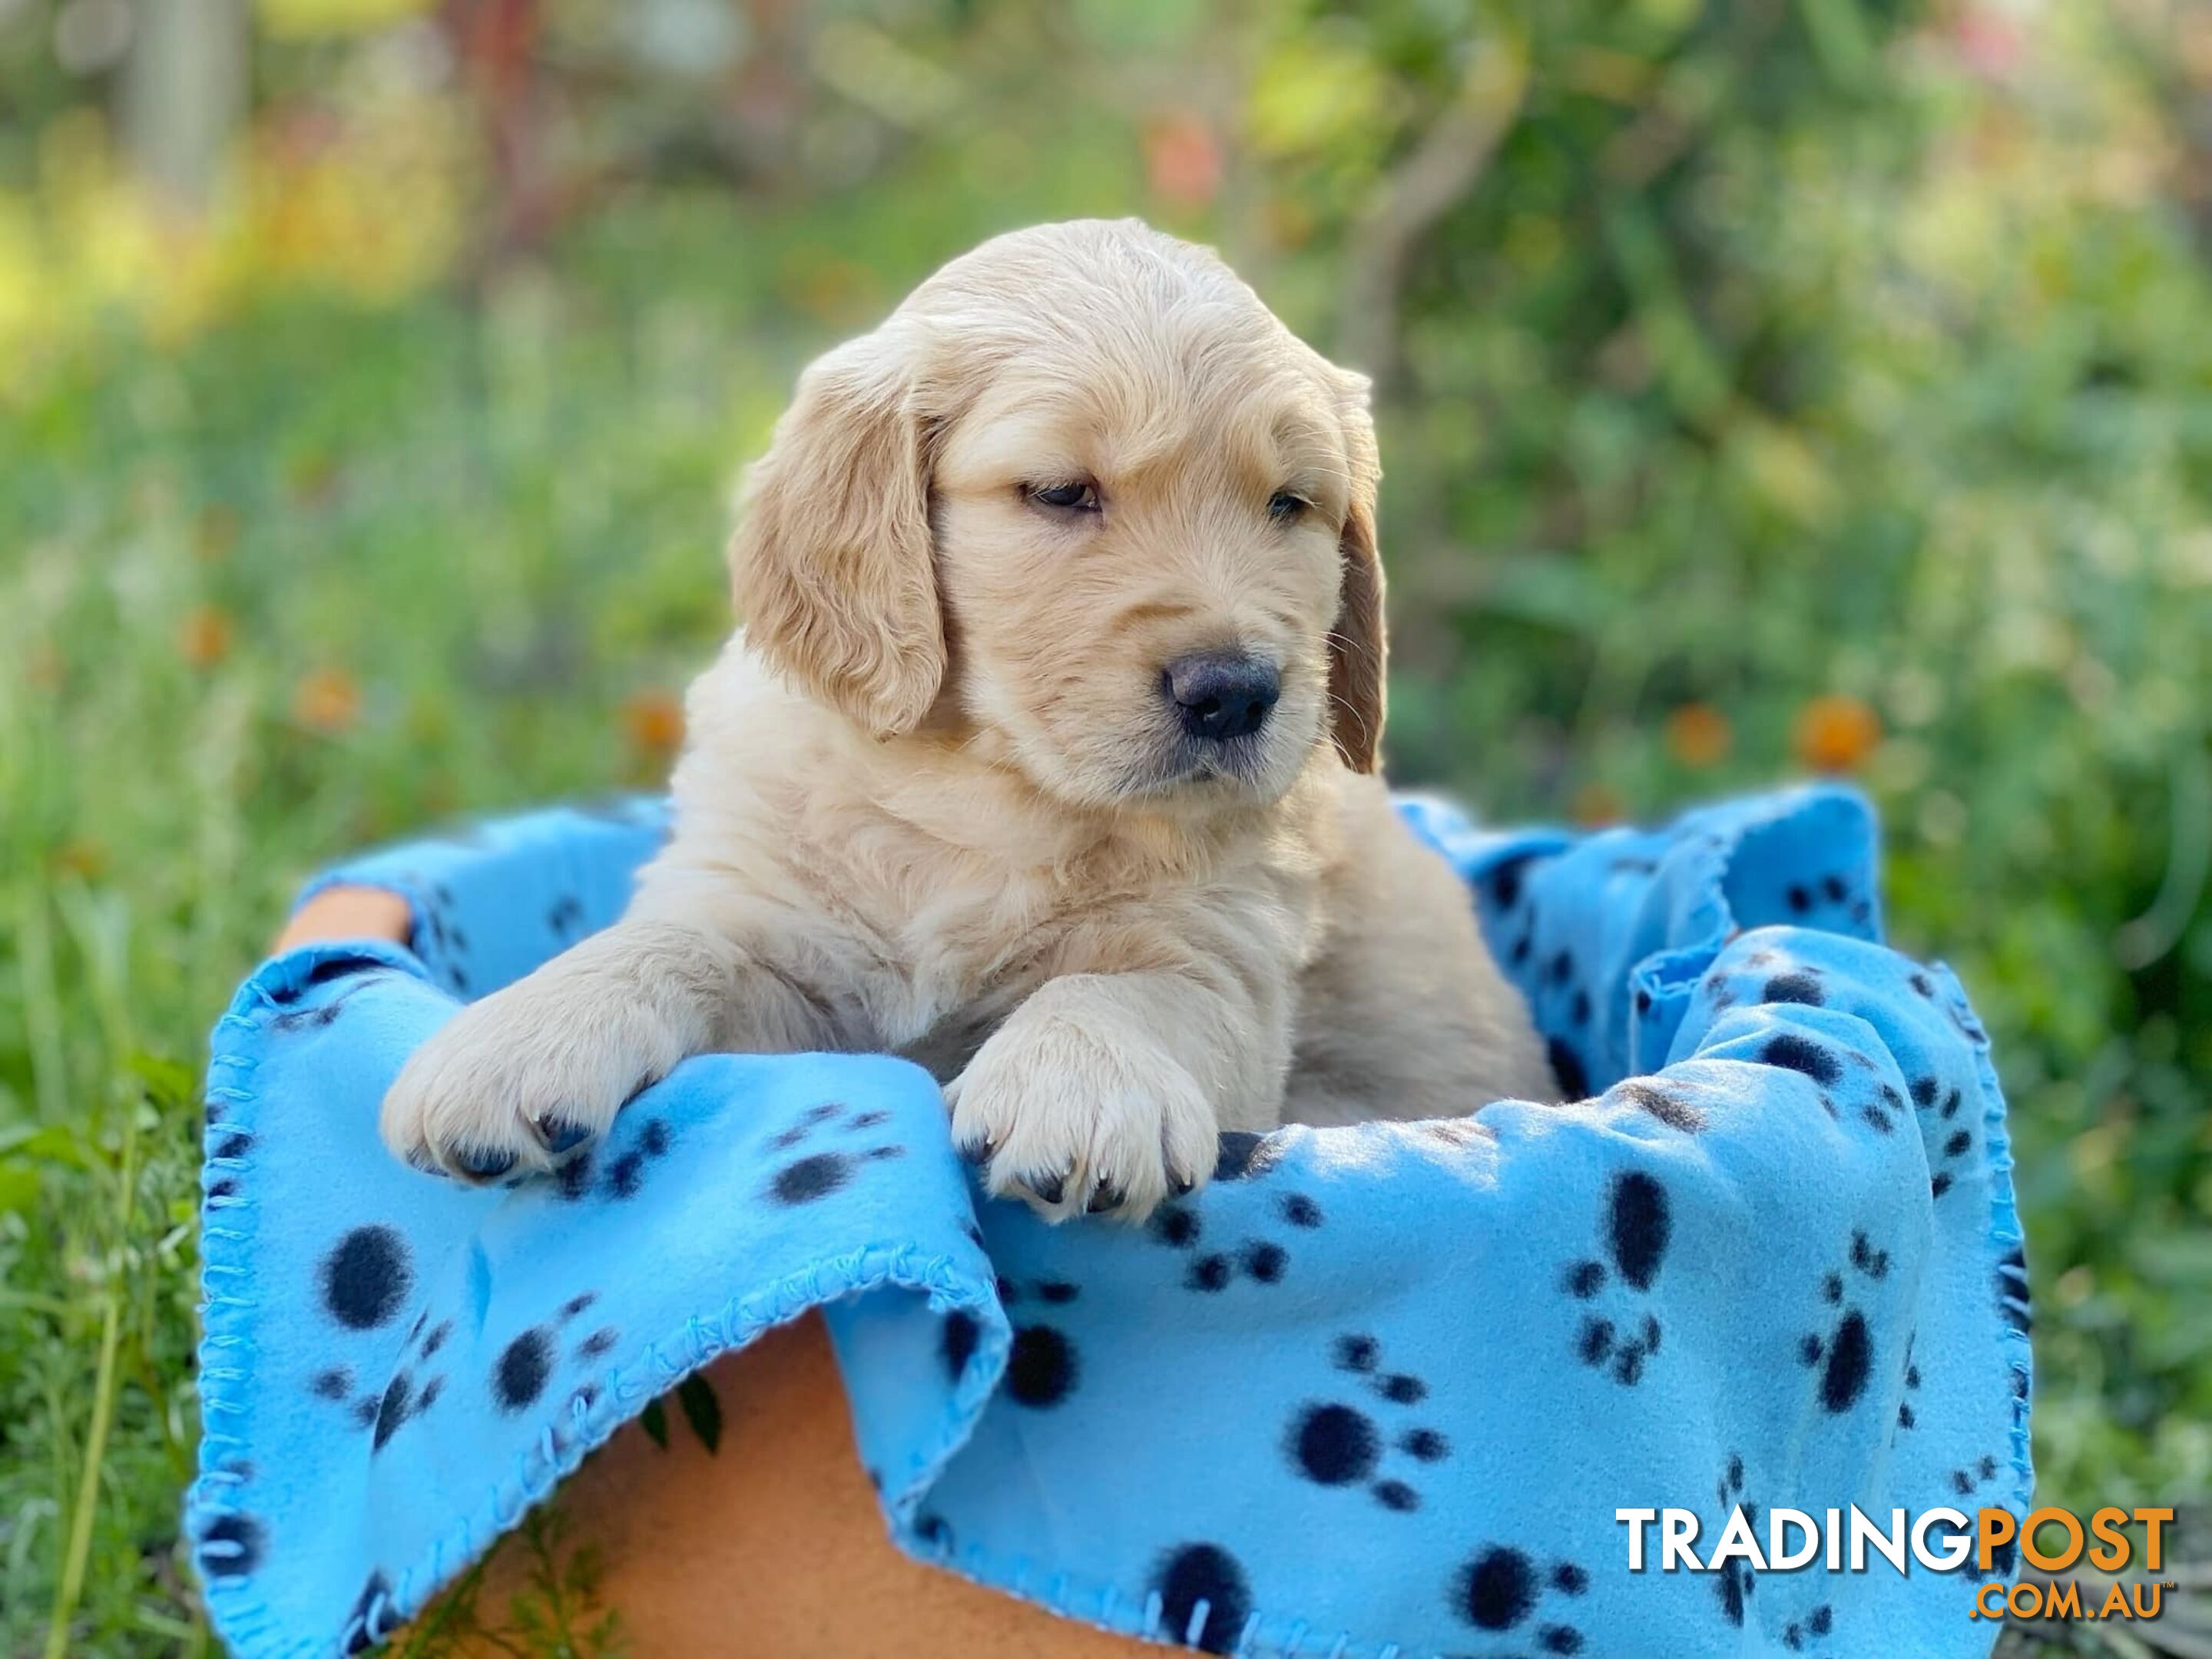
left=121, top=0, right=252, bottom=219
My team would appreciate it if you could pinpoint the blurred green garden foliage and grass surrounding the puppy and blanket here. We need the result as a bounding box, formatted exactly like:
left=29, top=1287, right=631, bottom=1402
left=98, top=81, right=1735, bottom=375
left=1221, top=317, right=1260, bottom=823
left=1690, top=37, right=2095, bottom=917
left=0, top=0, right=2212, bottom=1654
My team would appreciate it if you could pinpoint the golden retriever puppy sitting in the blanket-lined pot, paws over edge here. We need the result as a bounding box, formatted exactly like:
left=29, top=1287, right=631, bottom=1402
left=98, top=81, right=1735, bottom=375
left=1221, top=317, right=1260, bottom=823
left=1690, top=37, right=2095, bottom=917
left=382, top=221, right=1553, bottom=1219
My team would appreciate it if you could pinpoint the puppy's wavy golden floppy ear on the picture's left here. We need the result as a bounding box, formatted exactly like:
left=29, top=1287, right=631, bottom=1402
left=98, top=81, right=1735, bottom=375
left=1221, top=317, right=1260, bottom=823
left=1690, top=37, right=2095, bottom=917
left=730, top=316, right=945, bottom=737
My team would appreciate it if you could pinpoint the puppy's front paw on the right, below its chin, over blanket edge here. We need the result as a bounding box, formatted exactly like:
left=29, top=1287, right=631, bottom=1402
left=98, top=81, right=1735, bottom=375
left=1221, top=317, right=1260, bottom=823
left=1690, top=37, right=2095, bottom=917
left=945, top=1000, right=1219, bottom=1221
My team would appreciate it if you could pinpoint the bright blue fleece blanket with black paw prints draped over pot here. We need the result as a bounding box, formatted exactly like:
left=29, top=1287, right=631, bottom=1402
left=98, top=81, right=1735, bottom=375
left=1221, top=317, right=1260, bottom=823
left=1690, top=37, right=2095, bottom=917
left=188, top=790, right=2031, bottom=1659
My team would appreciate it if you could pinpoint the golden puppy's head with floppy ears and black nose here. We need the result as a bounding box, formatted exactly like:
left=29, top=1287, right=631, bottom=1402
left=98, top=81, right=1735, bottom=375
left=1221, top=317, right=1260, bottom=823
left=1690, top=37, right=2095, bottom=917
left=732, top=221, right=1382, bottom=807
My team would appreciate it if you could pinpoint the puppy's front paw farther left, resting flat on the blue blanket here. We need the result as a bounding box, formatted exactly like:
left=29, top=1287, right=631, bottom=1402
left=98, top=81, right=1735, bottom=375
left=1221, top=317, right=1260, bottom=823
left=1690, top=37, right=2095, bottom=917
left=378, top=980, right=666, bottom=1181
